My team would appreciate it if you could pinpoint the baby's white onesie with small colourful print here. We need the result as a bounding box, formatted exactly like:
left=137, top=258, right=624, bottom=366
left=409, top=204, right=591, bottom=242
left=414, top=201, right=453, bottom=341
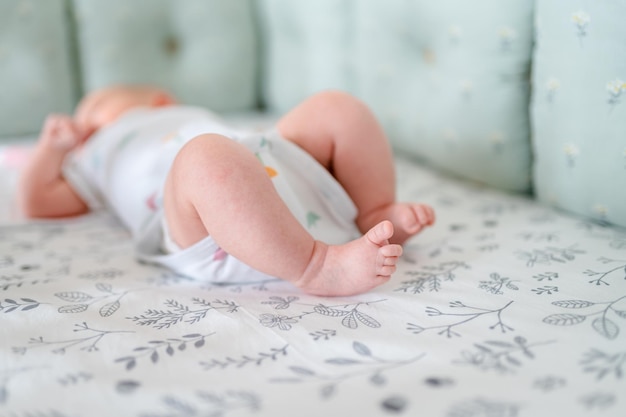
left=63, top=106, right=359, bottom=282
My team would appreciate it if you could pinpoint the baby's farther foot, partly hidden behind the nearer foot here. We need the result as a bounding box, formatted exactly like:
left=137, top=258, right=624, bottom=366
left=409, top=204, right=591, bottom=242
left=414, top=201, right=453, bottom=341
left=356, top=203, right=435, bottom=245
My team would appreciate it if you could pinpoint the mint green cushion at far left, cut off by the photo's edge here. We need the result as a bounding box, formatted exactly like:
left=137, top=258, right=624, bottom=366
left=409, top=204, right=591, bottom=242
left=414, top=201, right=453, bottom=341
left=0, top=0, right=78, bottom=138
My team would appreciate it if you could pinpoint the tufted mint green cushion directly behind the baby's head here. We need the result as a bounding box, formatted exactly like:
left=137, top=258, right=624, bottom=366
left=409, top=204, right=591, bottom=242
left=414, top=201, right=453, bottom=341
left=73, top=0, right=258, bottom=111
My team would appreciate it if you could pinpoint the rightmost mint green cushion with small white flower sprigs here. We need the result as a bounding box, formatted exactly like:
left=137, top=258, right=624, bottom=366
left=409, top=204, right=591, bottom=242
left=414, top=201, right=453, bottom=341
left=532, top=0, right=626, bottom=226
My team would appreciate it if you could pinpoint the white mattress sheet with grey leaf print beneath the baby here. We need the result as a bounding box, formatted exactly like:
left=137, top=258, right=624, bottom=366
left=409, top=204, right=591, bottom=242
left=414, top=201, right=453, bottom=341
left=0, top=141, right=626, bottom=417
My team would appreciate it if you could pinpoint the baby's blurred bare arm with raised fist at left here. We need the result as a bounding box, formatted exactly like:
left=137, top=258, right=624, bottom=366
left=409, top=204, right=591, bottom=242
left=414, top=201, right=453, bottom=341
left=18, top=115, right=89, bottom=218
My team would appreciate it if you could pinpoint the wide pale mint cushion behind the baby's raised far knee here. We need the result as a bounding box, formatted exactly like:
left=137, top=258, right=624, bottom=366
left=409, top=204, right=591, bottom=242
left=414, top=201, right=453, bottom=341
left=260, top=0, right=533, bottom=191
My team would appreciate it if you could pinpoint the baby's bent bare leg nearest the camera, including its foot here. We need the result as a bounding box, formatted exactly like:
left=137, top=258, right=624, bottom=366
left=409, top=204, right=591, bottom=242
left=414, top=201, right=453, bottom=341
left=164, top=135, right=402, bottom=295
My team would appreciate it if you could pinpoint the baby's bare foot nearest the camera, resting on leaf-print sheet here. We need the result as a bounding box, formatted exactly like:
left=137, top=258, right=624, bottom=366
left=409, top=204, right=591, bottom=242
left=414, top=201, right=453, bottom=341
left=296, top=221, right=402, bottom=296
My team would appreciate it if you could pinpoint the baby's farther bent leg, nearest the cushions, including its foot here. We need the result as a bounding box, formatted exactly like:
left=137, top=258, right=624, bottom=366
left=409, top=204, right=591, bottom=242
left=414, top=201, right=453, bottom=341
left=278, top=91, right=434, bottom=244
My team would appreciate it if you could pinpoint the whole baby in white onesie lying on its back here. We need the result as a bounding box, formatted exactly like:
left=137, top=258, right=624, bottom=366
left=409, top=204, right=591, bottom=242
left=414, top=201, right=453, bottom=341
left=19, top=86, right=435, bottom=296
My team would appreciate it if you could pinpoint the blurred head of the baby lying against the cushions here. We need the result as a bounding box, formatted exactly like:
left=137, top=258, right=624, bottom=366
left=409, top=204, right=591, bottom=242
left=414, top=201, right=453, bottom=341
left=74, top=85, right=176, bottom=136
